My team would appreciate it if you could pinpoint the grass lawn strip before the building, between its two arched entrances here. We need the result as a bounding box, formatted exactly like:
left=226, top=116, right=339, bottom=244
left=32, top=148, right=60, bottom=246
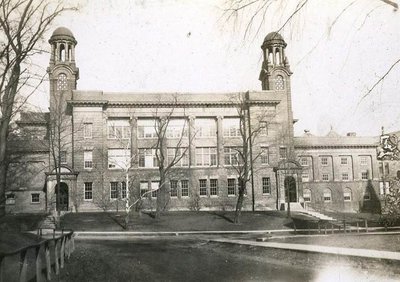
left=61, top=211, right=316, bottom=231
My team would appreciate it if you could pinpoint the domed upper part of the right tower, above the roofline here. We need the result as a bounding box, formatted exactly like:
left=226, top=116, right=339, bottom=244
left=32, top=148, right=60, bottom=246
left=259, top=32, right=292, bottom=90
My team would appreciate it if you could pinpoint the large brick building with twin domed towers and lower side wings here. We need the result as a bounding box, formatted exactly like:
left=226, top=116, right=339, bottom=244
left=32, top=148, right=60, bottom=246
left=6, top=28, right=380, bottom=212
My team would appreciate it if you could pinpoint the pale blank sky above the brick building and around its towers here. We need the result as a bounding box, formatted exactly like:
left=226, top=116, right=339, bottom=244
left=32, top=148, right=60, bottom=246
left=31, top=0, right=400, bottom=136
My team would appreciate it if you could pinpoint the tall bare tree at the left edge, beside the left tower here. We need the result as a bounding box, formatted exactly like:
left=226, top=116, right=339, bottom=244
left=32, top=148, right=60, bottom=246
left=0, top=0, right=75, bottom=215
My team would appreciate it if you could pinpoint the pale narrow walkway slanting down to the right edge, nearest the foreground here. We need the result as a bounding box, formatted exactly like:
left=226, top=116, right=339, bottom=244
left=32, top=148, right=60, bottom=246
left=211, top=239, right=400, bottom=261
